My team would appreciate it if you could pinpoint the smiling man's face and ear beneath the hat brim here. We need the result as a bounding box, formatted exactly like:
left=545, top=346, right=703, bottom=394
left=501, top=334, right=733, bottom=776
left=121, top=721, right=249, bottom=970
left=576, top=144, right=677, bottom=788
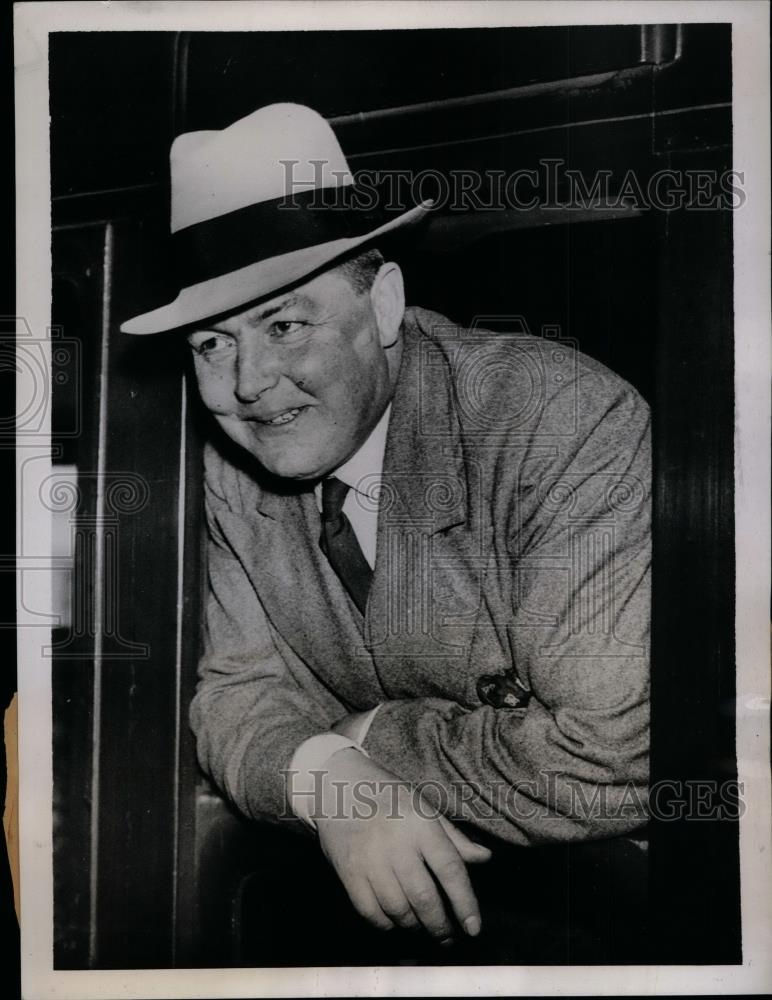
left=188, top=264, right=404, bottom=479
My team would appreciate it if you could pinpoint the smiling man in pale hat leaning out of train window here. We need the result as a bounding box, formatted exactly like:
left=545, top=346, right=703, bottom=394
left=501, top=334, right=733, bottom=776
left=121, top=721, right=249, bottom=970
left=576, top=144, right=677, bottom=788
left=123, top=105, right=650, bottom=960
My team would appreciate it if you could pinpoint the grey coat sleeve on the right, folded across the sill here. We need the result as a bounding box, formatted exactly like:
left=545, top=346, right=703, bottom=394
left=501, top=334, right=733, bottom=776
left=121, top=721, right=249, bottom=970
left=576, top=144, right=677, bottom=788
left=364, top=376, right=651, bottom=844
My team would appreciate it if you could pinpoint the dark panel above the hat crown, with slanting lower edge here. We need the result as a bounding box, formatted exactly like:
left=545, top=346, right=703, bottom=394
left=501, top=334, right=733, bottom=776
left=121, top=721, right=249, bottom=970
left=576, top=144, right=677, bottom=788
left=186, top=25, right=651, bottom=130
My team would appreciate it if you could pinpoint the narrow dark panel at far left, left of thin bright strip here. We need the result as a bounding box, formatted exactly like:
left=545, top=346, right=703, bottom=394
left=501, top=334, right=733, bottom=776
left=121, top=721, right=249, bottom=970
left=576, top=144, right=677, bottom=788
left=51, top=225, right=105, bottom=969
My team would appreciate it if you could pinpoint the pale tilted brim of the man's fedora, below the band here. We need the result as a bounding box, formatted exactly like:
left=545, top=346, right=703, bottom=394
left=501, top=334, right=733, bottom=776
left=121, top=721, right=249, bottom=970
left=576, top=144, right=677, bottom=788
left=121, top=201, right=432, bottom=336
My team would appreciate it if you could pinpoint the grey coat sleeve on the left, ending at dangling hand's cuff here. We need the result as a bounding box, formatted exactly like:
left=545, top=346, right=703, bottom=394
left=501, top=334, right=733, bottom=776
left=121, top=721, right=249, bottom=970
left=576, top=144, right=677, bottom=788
left=190, top=460, right=344, bottom=819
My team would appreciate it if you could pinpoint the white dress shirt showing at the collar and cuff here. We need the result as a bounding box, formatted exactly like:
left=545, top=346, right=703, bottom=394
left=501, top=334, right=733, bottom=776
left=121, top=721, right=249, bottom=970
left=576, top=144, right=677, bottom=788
left=290, top=403, right=391, bottom=827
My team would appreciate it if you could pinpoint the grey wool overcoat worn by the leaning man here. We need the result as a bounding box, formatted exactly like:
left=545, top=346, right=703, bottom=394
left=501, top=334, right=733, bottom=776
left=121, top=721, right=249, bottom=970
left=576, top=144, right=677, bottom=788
left=191, top=308, right=651, bottom=844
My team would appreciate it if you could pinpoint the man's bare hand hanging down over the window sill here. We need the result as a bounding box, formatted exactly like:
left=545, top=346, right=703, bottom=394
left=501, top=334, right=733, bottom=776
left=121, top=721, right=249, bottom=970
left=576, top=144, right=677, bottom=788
left=317, top=749, right=491, bottom=943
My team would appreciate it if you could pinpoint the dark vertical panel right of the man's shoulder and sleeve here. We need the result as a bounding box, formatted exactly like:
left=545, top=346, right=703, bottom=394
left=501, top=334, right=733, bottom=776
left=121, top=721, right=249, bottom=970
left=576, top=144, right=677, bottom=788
left=652, top=149, right=740, bottom=964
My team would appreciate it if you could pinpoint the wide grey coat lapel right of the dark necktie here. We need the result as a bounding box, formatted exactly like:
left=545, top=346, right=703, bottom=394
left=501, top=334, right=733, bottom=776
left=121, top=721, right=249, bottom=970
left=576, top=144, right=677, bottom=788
left=365, top=312, right=490, bottom=703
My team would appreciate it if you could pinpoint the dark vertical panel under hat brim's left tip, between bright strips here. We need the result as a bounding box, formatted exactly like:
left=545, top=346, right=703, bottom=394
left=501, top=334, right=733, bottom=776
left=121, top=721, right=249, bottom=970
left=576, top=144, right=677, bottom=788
left=88, top=223, right=183, bottom=968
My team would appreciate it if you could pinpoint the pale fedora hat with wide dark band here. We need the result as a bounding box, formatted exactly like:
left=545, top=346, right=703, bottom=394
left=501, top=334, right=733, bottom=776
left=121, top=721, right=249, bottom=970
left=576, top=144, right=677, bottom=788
left=121, top=104, right=431, bottom=334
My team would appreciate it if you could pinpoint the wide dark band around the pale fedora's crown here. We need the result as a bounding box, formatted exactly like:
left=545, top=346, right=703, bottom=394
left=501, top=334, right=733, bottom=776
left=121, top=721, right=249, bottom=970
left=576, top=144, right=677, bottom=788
left=172, top=185, right=387, bottom=288
